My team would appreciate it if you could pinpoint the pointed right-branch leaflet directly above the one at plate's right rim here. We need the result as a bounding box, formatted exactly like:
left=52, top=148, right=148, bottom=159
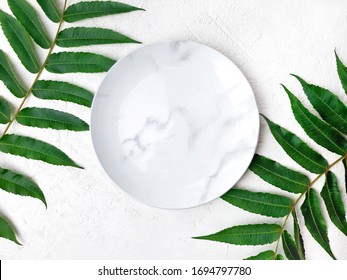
left=283, top=86, right=347, bottom=155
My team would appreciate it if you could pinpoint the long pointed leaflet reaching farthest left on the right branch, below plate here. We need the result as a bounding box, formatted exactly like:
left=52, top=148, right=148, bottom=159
left=194, top=224, right=281, bottom=245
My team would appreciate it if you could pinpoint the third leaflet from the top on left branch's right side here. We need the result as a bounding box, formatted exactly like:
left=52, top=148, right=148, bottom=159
left=46, top=52, right=116, bottom=74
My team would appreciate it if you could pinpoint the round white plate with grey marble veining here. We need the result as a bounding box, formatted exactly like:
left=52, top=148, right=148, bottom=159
left=91, top=41, right=259, bottom=209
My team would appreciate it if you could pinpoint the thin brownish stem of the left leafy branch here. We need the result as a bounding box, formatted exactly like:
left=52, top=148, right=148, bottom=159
left=0, top=0, right=68, bottom=139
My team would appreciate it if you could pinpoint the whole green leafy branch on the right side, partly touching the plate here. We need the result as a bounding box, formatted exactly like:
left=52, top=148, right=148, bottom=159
left=195, top=53, right=347, bottom=260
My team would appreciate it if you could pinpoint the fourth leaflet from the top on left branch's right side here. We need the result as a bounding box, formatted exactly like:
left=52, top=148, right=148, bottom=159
left=32, top=80, right=93, bottom=107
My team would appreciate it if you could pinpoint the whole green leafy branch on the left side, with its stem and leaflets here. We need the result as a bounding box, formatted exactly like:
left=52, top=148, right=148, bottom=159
left=0, top=0, right=143, bottom=244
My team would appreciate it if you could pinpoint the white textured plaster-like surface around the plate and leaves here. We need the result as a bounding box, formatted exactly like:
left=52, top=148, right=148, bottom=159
left=0, top=0, right=347, bottom=259
